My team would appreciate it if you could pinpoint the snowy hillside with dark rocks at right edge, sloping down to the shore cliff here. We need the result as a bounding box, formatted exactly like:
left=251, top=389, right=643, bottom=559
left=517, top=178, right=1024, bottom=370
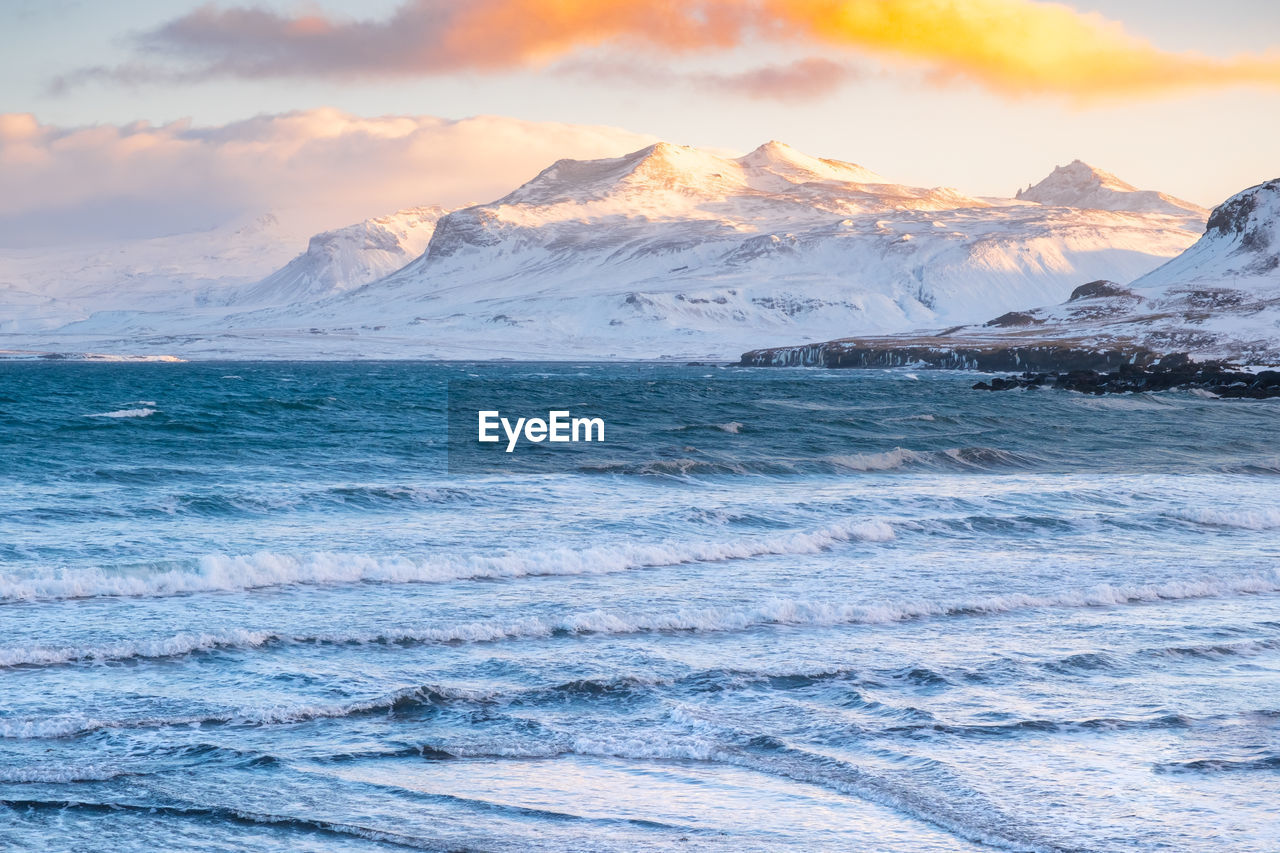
left=748, top=179, right=1280, bottom=365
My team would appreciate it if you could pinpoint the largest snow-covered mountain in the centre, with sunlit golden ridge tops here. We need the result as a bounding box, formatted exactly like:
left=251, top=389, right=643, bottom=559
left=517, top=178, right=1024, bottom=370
left=0, top=142, right=1218, bottom=357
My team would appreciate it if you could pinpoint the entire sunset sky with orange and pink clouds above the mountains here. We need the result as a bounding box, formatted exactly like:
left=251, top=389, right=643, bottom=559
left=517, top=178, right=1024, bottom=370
left=0, top=0, right=1280, bottom=246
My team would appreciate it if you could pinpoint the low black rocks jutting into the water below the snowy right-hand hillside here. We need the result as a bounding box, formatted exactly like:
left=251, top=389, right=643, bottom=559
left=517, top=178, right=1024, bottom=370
left=974, top=353, right=1280, bottom=400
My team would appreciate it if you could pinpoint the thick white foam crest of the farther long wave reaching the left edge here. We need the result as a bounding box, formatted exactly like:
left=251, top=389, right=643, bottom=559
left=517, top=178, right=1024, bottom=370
left=0, top=520, right=893, bottom=601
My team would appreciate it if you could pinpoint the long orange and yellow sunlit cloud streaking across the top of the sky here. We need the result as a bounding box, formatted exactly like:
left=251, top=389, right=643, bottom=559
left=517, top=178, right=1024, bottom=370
left=54, top=0, right=1280, bottom=99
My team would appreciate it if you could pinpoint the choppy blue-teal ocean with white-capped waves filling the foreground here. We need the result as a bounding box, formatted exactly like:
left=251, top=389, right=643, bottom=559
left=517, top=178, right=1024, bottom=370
left=0, top=362, right=1280, bottom=853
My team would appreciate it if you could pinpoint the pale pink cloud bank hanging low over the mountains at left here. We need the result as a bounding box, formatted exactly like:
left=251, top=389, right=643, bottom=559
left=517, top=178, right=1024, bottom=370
left=0, top=109, right=654, bottom=246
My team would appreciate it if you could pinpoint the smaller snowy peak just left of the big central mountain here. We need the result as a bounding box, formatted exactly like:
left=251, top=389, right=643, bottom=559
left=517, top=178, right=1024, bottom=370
left=236, top=206, right=448, bottom=305
